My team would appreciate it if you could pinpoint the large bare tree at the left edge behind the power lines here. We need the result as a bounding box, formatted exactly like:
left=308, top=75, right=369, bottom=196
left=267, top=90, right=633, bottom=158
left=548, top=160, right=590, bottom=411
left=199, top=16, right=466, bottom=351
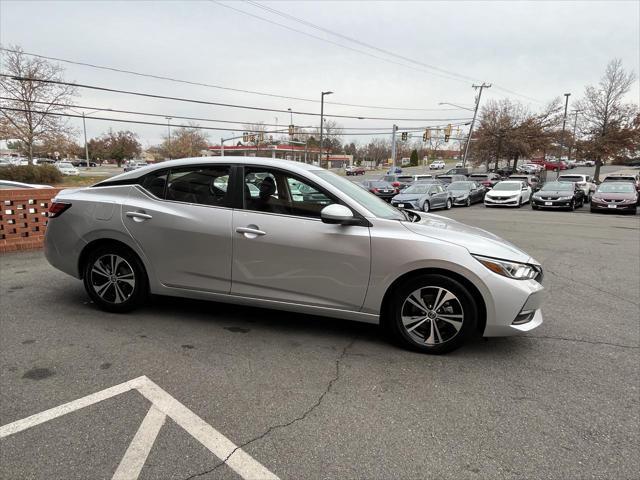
left=0, top=46, right=76, bottom=162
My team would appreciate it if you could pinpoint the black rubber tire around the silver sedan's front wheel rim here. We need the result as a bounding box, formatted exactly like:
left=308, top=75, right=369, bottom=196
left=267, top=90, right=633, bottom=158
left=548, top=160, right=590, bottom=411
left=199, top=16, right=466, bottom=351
left=383, top=274, right=478, bottom=354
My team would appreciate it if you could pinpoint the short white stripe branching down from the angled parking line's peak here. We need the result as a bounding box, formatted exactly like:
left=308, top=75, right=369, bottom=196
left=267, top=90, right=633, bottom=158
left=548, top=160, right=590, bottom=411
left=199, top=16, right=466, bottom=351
left=112, top=405, right=167, bottom=480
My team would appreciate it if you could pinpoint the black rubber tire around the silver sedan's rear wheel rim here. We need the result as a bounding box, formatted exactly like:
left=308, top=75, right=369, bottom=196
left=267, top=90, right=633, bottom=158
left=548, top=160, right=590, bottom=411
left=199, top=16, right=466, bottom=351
left=83, top=244, right=149, bottom=313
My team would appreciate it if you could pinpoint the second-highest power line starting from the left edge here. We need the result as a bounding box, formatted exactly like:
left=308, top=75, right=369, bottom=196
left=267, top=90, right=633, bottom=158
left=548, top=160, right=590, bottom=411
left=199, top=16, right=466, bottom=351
left=0, top=74, right=467, bottom=122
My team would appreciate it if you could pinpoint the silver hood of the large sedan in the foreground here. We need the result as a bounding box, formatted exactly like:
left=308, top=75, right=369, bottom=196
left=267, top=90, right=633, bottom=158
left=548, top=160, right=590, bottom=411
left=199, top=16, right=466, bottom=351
left=402, top=213, right=538, bottom=265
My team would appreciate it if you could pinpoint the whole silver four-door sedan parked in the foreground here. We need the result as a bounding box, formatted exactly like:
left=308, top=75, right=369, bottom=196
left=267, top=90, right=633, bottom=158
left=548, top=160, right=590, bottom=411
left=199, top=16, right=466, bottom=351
left=45, top=157, right=543, bottom=353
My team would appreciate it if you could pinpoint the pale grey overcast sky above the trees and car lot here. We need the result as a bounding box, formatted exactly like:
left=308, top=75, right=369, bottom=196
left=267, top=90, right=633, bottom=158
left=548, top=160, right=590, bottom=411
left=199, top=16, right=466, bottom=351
left=0, top=0, right=640, bottom=146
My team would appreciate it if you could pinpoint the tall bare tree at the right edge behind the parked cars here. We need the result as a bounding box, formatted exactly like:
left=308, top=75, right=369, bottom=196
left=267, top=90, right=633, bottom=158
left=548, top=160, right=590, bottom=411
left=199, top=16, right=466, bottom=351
left=578, top=58, right=638, bottom=182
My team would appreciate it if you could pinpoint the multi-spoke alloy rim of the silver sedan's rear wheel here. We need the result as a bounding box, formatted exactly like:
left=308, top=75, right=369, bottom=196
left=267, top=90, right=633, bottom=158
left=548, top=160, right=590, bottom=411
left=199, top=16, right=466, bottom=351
left=90, top=253, right=136, bottom=304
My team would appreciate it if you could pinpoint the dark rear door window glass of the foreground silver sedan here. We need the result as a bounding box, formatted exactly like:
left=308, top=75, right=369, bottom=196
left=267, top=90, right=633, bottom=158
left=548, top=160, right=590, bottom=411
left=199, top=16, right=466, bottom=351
left=167, top=165, right=229, bottom=207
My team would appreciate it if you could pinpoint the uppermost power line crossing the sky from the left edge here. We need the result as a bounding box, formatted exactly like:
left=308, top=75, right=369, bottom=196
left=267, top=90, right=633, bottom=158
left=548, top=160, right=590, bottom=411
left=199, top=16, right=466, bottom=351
left=0, top=47, right=459, bottom=112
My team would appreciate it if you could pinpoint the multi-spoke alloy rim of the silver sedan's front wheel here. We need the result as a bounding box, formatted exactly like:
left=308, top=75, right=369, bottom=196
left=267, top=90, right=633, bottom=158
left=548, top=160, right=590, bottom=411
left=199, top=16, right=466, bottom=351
left=400, top=287, right=464, bottom=346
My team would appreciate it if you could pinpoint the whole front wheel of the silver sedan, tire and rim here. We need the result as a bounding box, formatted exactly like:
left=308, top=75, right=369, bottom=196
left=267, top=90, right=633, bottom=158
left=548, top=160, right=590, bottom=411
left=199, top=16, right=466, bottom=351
left=385, top=274, right=477, bottom=354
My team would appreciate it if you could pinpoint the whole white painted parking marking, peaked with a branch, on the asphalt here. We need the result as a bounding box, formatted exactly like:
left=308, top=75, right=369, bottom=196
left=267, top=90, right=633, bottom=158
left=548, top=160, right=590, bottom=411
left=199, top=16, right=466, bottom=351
left=0, top=376, right=279, bottom=480
